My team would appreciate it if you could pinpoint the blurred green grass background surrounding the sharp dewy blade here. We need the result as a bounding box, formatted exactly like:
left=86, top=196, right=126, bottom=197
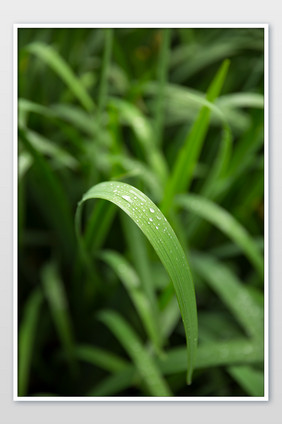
left=18, top=27, right=264, bottom=397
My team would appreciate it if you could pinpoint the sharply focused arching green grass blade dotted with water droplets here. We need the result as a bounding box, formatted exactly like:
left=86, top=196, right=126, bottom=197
left=76, top=182, right=198, bottom=382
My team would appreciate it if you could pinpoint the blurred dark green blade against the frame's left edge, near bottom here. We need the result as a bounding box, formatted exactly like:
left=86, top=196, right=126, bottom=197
left=18, top=289, right=43, bottom=396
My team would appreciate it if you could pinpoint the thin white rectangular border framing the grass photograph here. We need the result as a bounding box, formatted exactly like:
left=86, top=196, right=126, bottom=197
left=13, top=23, right=269, bottom=402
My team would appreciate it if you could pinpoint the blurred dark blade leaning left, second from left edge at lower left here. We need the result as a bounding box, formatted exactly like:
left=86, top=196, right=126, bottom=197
left=42, top=263, right=77, bottom=373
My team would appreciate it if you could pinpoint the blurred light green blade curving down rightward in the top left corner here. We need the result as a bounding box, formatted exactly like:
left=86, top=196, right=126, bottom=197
left=27, top=42, right=95, bottom=112
